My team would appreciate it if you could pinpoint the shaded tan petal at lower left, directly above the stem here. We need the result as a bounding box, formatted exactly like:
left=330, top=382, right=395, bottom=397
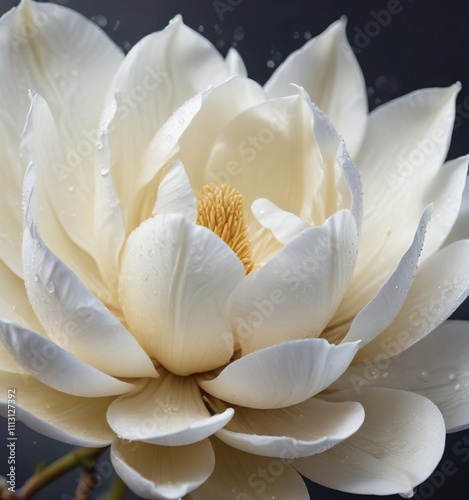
left=0, top=374, right=114, bottom=447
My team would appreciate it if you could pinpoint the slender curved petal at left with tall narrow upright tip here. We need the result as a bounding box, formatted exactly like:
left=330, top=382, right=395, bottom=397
left=23, top=165, right=156, bottom=377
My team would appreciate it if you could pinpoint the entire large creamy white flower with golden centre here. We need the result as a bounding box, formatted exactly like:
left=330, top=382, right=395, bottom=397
left=0, top=0, right=469, bottom=500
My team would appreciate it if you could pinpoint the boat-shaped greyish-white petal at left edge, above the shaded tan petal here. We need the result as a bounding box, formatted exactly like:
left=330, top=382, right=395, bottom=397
left=0, top=321, right=133, bottom=398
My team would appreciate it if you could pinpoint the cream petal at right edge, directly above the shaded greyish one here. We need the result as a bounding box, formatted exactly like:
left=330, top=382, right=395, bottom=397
left=354, top=240, right=469, bottom=362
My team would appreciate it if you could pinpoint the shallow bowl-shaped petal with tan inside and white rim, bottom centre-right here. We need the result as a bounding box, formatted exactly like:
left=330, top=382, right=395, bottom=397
left=216, top=398, right=365, bottom=458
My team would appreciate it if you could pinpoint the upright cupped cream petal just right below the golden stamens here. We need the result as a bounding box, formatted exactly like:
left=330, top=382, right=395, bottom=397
left=229, top=210, right=358, bottom=355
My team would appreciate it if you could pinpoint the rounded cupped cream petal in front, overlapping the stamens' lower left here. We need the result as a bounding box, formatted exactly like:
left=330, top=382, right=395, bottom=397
left=121, top=214, right=245, bottom=375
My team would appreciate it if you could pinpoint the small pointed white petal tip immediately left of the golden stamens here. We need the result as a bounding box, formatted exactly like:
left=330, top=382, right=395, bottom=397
left=152, top=161, right=197, bottom=223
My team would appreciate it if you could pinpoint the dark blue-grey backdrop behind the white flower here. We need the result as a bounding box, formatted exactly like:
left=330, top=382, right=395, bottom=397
left=0, top=0, right=469, bottom=500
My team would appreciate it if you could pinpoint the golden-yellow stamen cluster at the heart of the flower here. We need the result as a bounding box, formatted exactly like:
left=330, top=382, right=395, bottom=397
left=197, top=184, right=254, bottom=274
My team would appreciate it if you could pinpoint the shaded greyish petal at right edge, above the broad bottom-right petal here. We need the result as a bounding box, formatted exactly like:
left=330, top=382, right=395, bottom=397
left=334, top=321, right=469, bottom=432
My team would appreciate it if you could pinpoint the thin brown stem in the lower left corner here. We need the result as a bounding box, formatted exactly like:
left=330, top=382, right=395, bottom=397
left=0, top=448, right=104, bottom=500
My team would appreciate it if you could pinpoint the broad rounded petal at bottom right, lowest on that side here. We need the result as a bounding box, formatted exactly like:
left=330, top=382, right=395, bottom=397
left=292, top=388, right=445, bottom=496
